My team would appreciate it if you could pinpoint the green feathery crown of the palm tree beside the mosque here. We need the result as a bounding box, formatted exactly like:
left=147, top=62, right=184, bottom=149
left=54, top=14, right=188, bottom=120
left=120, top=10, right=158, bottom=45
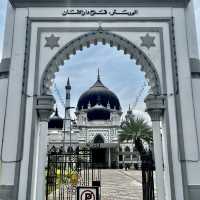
left=119, top=117, right=153, bottom=151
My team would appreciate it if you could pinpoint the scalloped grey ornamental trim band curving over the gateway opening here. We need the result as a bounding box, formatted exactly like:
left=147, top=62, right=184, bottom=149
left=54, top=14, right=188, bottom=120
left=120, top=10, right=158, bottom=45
left=40, top=27, right=161, bottom=95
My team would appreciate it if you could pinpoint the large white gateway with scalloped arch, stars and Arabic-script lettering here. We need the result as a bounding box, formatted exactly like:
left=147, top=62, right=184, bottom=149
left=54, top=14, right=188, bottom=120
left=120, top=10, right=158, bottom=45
left=0, top=0, right=200, bottom=200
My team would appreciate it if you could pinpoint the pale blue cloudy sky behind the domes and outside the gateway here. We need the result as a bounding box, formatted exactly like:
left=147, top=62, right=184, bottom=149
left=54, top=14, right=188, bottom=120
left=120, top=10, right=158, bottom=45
left=0, top=0, right=200, bottom=118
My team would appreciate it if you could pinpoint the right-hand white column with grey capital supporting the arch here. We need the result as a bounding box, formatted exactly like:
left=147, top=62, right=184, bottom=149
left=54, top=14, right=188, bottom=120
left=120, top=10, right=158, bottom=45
left=145, top=95, right=165, bottom=200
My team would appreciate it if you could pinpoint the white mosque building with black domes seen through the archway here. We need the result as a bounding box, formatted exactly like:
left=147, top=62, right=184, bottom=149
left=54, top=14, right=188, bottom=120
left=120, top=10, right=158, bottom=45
left=48, top=73, right=139, bottom=168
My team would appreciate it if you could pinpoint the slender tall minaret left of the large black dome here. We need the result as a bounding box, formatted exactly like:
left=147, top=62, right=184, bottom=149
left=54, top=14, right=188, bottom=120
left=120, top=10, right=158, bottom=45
left=65, top=78, right=71, bottom=132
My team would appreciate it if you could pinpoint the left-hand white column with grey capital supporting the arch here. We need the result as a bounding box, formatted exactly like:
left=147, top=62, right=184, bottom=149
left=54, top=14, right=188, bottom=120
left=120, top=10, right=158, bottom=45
left=36, top=96, right=54, bottom=200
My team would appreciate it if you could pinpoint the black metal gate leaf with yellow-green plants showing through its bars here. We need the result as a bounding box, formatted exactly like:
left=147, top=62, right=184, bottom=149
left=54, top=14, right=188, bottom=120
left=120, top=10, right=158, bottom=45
left=46, top=150, right=101, bottom=200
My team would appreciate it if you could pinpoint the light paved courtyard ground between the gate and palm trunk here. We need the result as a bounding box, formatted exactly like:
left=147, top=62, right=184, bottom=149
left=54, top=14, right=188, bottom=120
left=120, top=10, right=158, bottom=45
left=101, top=169, right=142, bottom=200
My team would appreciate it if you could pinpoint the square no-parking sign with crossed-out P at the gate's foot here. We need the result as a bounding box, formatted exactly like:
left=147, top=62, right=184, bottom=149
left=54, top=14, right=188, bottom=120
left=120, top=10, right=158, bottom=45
left=77, top=187, right=99, bottom=200
